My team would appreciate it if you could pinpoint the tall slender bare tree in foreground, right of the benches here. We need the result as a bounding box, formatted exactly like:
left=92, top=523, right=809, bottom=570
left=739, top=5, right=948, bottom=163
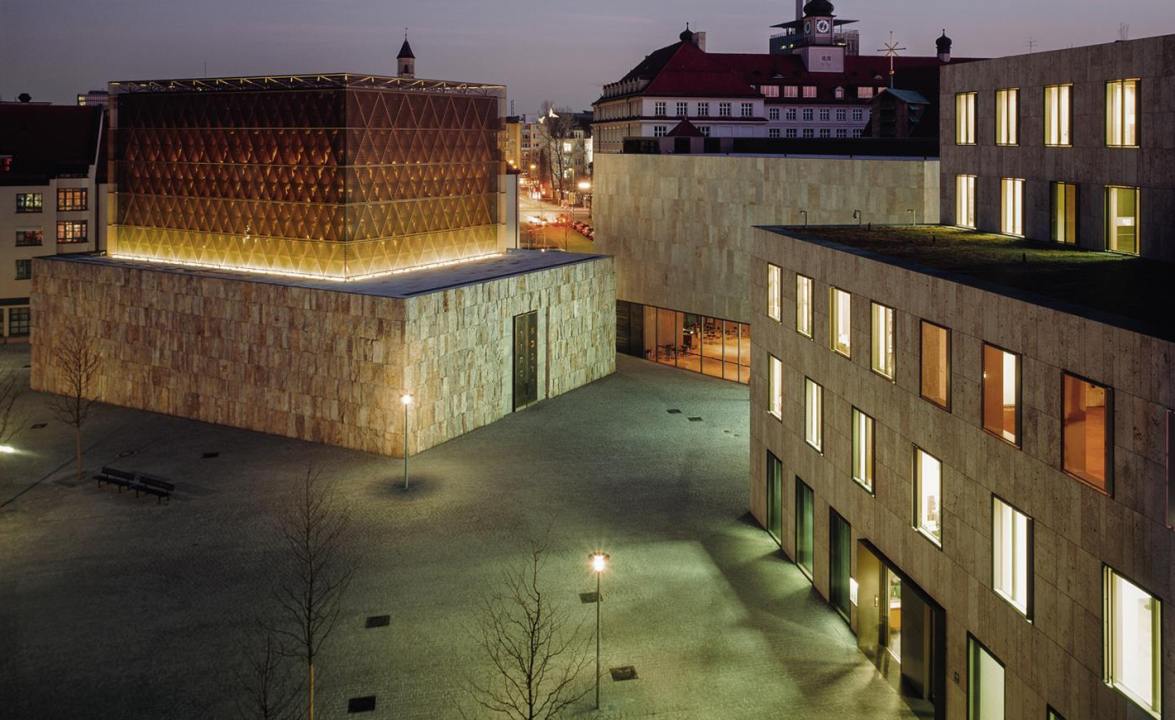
left=274, top=467, right=355, bottom=720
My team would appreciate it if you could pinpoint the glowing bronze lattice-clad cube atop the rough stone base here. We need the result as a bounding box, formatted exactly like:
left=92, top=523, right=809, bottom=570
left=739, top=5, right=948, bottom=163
left=108, top=75, right=503, bottom=278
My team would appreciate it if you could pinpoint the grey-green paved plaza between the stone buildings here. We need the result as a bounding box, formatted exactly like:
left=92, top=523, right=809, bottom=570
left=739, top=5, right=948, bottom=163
left=0, top=346, right=911, bottom=720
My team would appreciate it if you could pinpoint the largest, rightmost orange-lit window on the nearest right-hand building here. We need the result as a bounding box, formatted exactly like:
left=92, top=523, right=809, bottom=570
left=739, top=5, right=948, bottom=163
left=1061, top=372, right=1113, bottom=494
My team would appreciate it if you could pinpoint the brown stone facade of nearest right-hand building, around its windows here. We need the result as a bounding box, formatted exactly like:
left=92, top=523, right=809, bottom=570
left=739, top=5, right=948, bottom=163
left=748, top=230, right=1175, bottom=720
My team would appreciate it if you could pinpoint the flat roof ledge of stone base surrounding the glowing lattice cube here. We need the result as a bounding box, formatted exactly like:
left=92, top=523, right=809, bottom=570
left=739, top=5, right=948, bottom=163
left=45, top=250, right=606, bottom=298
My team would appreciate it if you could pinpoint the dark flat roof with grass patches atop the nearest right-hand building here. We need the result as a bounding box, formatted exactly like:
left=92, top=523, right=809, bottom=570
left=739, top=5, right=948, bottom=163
left=763, top=226, right=1175, bottom=342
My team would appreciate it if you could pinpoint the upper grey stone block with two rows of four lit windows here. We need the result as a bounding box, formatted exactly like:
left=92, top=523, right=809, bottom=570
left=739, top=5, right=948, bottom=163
left=940, top=35, right=1175, bottom=261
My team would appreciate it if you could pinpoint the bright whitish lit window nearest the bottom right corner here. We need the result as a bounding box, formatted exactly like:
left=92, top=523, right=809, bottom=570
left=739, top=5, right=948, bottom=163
left=1102, top=566, right=1163, bottom=718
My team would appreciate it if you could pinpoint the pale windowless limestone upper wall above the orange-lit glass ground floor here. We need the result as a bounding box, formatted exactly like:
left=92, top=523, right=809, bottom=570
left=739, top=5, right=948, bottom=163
left=592, top=154, right=939, bottom=322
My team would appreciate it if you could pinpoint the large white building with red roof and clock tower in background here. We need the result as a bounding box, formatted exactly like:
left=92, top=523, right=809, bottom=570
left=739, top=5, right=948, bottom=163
left=595, top=0, right=952, bottom=154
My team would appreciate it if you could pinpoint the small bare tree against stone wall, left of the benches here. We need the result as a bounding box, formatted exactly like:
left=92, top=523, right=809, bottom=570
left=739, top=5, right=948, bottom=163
left=49, top=318, right=102, bottom=480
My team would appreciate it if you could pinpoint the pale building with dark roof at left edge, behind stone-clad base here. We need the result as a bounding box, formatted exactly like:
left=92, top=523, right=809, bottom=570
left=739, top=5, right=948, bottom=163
left=0, top=102, right=106, bottom=341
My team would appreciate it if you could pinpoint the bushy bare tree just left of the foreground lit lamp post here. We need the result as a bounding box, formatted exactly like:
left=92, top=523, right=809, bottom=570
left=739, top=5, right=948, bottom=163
left=468, top=543, right=591, bottom=720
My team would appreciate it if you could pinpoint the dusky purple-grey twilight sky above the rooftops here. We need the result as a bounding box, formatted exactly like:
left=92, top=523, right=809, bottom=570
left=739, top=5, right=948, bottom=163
left=0, top=0, right=1175, bottom=113
